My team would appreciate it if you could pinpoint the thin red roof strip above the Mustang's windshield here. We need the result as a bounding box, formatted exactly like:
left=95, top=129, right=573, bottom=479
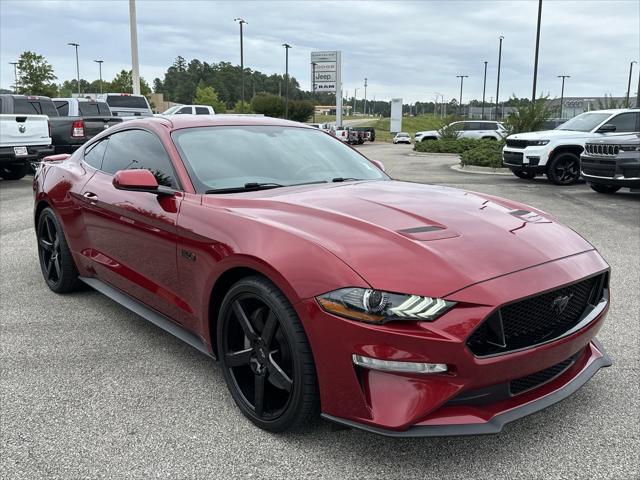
left=120, top=115, right=315, bottom=130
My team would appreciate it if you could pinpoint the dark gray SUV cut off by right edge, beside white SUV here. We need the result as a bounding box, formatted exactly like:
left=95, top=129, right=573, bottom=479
left=580, top=133, right=640, bottom=193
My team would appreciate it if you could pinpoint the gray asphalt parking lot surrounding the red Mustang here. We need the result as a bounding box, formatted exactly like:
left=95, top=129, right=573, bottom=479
left=0, top=144, right=640, bottom=479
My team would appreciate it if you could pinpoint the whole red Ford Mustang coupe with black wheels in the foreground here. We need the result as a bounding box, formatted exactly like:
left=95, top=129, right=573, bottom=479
left=34, top=115, right=611, bottom=436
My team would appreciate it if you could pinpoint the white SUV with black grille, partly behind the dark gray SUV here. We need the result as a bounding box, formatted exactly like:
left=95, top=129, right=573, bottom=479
left=502, top=108, right=640, bottom=185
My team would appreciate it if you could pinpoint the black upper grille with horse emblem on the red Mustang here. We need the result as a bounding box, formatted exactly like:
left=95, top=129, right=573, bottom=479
left=467, top=274, right=606, bottom=357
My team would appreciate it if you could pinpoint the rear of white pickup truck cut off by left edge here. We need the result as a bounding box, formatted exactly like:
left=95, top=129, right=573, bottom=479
left=0, top=114, right=53, bottom=180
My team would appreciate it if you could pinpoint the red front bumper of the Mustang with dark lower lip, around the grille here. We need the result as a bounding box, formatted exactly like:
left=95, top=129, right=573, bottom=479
left=296, top=251, right=610, bottom=436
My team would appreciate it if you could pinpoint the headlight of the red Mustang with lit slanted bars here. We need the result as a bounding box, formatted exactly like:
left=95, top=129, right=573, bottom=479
left=316, top=287, right=455, bottom=324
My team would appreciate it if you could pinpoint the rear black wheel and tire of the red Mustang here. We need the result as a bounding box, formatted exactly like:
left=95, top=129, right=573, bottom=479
left=36, top=208, right=79, bottom=293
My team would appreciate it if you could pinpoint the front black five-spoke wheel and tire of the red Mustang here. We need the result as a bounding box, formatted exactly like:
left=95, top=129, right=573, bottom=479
left=217, top=277, right=318, bottom=432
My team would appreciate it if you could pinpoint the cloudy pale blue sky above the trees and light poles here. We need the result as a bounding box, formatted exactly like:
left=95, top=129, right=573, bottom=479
left=0, top=0, right=640, bottom=102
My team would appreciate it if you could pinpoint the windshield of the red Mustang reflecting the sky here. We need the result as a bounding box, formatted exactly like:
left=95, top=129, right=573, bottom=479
left=172, top=126, right=389, bottom=193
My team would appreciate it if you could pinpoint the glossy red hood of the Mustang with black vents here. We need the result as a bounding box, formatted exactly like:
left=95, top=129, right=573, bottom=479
left=203, top=181, right=593, bottom=297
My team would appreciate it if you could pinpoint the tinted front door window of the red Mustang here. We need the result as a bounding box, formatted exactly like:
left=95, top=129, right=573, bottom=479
left=102, top=130, right=178, bottom=188
